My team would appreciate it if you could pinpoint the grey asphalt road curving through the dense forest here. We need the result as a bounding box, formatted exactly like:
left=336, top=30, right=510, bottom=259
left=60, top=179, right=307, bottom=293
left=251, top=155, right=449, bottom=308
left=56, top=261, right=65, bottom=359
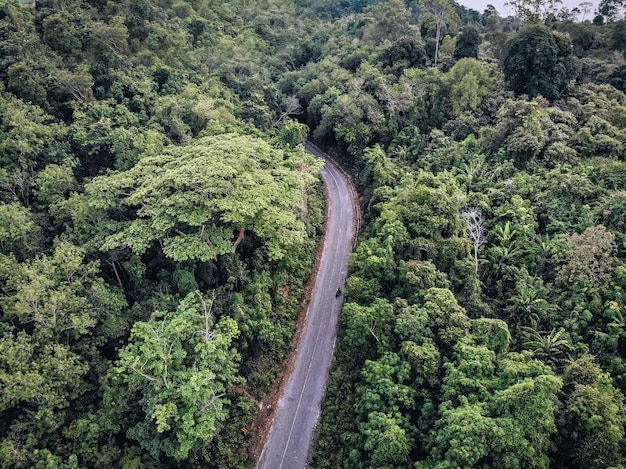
left=257, top=142, right=358, bottom=469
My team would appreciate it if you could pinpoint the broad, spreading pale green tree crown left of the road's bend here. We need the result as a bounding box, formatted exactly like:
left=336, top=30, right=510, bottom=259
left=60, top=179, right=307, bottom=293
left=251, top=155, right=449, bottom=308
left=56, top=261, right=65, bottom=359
left=87, top=135, right=319, bottom=261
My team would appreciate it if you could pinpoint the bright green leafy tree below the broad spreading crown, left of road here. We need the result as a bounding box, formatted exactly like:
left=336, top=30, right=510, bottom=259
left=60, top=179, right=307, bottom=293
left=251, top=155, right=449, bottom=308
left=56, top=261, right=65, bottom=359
left=117, top=292, right=239, bottom=460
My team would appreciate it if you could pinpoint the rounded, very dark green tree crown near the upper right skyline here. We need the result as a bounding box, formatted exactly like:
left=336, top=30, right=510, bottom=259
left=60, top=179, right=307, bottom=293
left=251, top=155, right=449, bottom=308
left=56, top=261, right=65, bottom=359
left=502, top=24, right=577, bottom=100
